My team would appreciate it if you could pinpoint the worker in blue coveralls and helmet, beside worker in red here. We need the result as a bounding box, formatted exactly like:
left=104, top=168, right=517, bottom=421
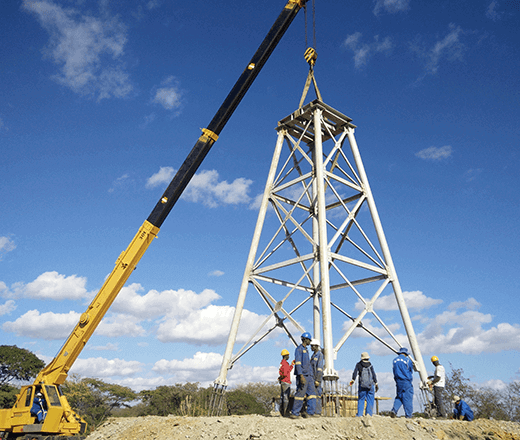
left=289, top=332, right=316, bottom=419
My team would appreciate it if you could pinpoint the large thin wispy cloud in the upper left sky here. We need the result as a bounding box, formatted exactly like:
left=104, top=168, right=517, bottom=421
left=22, top=0, right=133, bottom=100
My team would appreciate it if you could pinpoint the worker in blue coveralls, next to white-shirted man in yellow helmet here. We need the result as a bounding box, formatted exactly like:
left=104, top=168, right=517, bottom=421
left=390, top=347, right=413, bottom=419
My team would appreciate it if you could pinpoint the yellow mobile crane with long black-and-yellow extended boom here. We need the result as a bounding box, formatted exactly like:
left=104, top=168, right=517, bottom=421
left=0, top=0, right=308, bottom=438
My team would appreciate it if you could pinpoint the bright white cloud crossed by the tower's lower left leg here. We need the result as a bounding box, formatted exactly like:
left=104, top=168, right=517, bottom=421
left=157, top=305, right=272, bottom=345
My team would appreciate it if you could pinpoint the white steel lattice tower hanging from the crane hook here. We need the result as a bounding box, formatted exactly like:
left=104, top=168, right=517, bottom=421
left=209, top=99, right=428, bottom=411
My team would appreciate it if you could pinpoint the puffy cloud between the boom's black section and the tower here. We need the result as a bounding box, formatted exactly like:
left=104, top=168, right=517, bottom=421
left=182, top=170, right=253, bottom=208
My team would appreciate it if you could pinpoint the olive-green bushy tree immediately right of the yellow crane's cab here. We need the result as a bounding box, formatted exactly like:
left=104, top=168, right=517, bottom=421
left=63, top=376, right=137, bottom=431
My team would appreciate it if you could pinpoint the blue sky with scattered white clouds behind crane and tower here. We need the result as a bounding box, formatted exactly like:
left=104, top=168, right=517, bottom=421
left=0, top=0, right=520, bottom=412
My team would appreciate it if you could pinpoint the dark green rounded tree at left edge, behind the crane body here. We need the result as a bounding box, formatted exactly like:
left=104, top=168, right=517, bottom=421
left=0, top=345, right=45, bottom=386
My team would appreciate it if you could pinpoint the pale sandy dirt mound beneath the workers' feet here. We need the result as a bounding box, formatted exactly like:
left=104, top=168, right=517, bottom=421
left=87, top=415, right=520, bottom=440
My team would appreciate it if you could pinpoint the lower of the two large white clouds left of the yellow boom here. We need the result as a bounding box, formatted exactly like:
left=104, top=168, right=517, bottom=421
left=2, top=310, right=80, bottom=340
